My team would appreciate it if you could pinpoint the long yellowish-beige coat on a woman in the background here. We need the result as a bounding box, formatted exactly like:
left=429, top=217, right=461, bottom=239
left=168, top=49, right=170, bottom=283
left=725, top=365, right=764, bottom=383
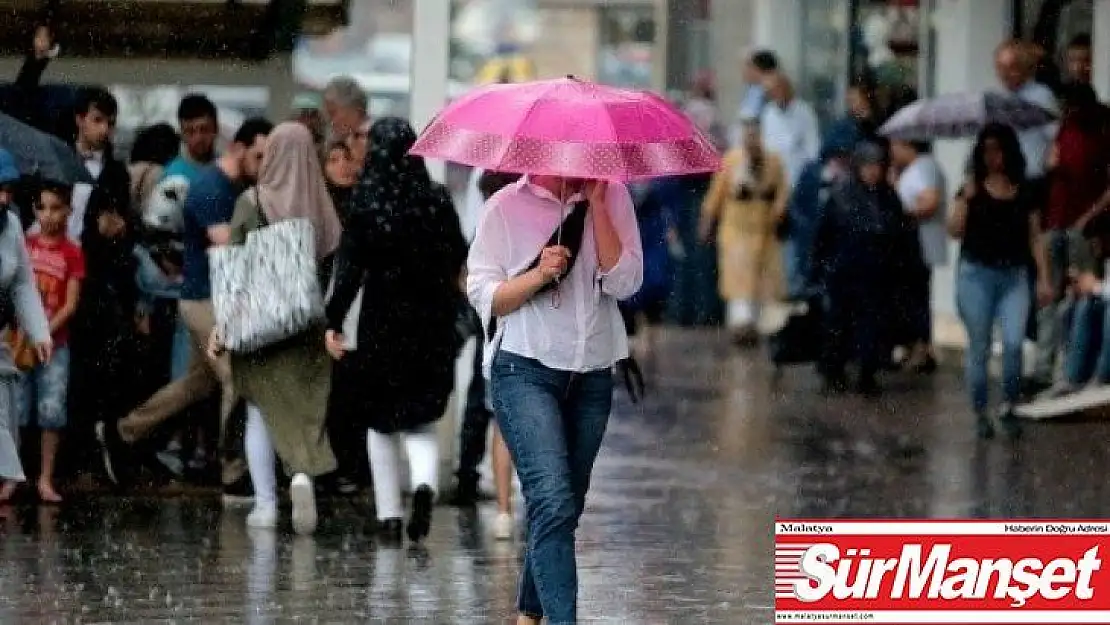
left=702, top=149, right=789, bottom=301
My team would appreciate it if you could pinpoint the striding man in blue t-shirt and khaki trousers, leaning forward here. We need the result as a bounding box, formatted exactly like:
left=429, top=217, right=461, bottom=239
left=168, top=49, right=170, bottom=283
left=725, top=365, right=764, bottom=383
left=97, top=119, right=273, bottom=485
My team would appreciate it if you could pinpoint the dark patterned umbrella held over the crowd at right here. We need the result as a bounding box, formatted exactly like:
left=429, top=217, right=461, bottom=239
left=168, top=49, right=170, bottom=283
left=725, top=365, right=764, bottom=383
left=879, top=92, right=1057, bottom=141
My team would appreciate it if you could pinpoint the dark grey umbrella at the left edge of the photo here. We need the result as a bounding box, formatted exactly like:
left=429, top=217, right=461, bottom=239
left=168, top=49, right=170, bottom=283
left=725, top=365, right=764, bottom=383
left=0, top=113, right=95, bottom=184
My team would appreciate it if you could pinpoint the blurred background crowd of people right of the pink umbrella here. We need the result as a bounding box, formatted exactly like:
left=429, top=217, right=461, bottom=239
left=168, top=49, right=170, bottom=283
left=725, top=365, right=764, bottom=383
left=634, top=36, right=1110, bottom=437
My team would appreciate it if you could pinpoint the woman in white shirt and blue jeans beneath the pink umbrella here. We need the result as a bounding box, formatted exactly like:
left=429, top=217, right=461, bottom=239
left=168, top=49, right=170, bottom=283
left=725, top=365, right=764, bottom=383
left=466, top=177, right=643, bottom=623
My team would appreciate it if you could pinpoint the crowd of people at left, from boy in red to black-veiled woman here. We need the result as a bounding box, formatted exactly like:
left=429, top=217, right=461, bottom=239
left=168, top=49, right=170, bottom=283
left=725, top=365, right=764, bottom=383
left=0, top=29, right=486, bottom=542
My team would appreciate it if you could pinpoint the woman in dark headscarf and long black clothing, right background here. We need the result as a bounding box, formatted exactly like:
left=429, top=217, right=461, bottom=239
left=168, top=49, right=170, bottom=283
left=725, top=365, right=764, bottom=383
left=814, top=142, right=915, bottom=394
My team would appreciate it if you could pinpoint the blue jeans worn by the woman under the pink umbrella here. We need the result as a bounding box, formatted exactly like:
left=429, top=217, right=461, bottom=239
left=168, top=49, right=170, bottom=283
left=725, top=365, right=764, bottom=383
left=490, top=351, right=613, bottom=625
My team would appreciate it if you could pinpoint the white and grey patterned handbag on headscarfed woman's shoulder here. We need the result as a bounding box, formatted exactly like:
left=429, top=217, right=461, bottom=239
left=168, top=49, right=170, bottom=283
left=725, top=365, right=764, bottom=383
left=209, top=219, right=324, bottom=353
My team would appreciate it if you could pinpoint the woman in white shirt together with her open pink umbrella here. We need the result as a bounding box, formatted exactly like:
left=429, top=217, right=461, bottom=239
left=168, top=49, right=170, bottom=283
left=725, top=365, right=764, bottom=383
left=412, top=78, right=720, bottom=624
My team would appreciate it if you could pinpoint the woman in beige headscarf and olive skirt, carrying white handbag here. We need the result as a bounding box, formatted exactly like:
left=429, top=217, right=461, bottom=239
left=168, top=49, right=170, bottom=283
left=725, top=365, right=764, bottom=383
left=220, top=122, right=342, bottom=533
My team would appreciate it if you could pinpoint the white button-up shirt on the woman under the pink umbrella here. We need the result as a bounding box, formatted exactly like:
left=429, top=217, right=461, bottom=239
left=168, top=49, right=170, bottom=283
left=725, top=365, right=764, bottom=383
left=466, top=178, right=644, bottom=376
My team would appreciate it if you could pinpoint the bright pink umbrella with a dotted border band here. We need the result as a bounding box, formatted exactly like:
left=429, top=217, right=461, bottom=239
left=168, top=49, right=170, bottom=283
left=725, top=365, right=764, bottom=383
left=412, top=78, right=720, bottom=182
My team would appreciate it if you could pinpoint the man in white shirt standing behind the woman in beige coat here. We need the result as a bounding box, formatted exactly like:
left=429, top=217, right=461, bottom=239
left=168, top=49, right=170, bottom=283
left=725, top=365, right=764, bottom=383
left=760, top=73, right=820, bottom=188
